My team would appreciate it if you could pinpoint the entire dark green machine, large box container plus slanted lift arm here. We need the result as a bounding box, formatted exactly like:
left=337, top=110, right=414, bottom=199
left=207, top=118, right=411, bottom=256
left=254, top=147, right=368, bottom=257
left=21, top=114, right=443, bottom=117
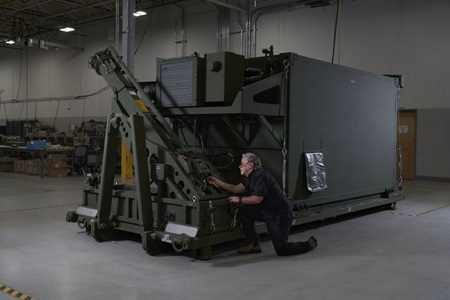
left=66, top=47, right=404, bottom=260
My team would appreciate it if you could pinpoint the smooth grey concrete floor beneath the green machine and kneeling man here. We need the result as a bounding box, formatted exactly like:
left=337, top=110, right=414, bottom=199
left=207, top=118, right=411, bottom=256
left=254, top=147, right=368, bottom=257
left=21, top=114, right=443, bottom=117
left=0, top=173, right=450, bottom=300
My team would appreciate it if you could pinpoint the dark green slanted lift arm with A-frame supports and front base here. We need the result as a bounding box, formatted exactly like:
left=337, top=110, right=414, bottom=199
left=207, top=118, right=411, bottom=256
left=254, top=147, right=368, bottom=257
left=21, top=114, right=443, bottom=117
left=67, top=48, right=240, bottom=258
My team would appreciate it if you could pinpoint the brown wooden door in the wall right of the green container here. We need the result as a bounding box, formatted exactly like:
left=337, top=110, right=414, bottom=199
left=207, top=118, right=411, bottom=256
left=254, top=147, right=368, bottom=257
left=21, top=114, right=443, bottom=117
left=397, top=110, right=416, bottom=180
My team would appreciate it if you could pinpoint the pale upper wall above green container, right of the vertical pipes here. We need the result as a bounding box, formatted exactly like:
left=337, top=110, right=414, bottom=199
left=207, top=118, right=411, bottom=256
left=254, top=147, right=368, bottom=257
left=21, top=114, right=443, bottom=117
left=257, top=0, right=450, bottom=108
